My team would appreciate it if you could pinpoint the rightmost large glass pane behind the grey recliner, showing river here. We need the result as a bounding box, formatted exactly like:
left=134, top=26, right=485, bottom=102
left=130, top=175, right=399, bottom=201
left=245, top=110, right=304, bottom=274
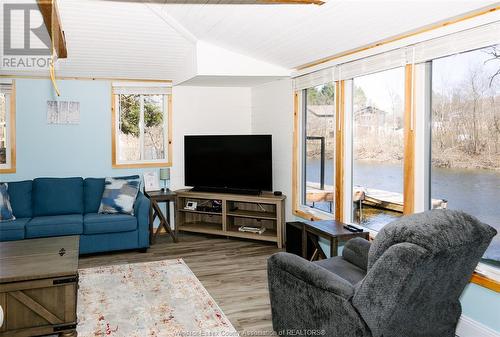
left=431, top=45, right=500, bottom=262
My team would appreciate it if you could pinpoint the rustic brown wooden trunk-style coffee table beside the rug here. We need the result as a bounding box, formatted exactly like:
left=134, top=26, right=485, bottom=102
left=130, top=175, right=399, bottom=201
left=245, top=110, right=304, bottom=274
left=0, top=236, right=80, bottom=337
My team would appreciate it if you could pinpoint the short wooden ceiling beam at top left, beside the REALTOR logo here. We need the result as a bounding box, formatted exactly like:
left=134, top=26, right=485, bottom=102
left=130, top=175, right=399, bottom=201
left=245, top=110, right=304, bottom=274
left=37, top=0, right=68, bottom=59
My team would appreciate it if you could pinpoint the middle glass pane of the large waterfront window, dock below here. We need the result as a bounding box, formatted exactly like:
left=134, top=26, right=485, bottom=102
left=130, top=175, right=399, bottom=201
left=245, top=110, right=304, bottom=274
left=352, top=67, right=405, bottom=230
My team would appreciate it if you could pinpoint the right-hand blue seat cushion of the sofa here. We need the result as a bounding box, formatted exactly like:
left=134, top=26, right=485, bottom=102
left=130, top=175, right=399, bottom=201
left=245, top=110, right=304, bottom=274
left=83, top=213, right=137, bottom=234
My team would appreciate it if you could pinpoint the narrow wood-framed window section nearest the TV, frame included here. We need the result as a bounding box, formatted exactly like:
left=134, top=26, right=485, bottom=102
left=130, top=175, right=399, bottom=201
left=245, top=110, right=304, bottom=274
left=292, top=76, right=342, bottom=220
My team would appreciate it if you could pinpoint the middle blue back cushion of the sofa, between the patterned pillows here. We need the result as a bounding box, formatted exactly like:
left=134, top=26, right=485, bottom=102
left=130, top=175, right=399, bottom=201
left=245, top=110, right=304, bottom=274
left=33, top=178, right=83, bottom=216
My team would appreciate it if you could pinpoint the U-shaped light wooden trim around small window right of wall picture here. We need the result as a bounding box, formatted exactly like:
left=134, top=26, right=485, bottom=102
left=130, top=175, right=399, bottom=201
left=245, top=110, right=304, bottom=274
left=111, top=87, right=173, bottom=169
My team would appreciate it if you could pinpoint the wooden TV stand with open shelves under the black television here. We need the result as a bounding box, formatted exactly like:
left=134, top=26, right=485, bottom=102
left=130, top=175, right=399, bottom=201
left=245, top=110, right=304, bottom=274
left=176, top=189, right=286, bottom=248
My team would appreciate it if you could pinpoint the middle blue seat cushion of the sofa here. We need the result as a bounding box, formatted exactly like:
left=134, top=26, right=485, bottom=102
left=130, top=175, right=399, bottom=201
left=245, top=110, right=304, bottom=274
left=26, top=214, right=83, bottom=238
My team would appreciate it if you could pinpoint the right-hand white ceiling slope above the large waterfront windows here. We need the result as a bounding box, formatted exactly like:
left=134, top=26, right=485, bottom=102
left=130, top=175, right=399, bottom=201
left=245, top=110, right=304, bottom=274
left=163, top=0, right=494, bottom=68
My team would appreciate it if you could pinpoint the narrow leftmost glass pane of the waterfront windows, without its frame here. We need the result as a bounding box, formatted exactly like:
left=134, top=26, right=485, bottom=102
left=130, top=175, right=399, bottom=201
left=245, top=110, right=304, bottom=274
left=302, top=82, right=335, bottom=213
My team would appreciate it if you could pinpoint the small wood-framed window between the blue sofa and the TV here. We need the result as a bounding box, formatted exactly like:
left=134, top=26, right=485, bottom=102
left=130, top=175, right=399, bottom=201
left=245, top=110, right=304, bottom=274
left=111, top=83, right=172, bottom=168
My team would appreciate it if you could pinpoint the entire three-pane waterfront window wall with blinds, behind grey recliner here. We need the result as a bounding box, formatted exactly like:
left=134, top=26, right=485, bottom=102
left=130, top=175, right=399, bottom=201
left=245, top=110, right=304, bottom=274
left=292, top=23, right=500, bottom=289
